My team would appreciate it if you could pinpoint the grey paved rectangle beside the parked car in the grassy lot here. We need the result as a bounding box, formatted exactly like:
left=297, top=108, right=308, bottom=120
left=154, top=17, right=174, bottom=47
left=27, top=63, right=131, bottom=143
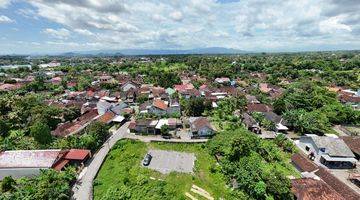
left=148, top=150, right=195, bottom=174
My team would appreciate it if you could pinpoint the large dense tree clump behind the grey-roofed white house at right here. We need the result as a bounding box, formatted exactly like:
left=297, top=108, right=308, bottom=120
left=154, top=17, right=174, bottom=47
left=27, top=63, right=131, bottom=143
left=274, top=81, right=360, bottom=135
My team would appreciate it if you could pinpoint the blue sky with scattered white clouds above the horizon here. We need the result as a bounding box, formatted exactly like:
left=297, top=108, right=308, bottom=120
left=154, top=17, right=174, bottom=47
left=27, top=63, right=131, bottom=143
left=0, top=0, right=360, bottom=54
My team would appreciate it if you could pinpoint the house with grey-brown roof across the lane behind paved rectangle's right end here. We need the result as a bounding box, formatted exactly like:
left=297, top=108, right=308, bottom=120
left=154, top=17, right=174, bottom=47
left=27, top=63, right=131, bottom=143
left=189, top=117, right=216, bottom=138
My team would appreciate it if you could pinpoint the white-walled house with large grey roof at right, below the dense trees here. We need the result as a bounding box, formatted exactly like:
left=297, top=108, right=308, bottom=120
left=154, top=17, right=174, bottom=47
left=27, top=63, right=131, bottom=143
left=299, top=134, right=357, bottom=169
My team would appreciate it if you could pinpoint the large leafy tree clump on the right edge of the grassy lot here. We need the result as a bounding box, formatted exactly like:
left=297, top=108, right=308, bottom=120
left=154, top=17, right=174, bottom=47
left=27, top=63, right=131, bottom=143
left=209, top=128, right=299, bottom=200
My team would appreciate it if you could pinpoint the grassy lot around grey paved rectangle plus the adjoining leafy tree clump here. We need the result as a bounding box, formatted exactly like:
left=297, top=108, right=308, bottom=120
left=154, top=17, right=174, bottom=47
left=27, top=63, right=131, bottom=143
left=94, top=128, right=299, bottom=199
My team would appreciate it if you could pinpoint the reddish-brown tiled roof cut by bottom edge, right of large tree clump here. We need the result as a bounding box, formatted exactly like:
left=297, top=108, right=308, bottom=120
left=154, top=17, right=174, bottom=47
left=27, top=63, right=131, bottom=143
left=291, top=178, right=346, bottom=200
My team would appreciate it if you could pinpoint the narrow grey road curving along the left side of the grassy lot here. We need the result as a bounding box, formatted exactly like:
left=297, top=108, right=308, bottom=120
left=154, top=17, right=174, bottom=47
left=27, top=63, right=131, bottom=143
left=72, top=122, right=129, bottom=200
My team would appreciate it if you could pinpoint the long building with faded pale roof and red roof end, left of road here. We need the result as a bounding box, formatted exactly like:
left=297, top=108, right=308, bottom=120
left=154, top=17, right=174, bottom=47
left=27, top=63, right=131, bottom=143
left=0, top=149, right=91, bottom=180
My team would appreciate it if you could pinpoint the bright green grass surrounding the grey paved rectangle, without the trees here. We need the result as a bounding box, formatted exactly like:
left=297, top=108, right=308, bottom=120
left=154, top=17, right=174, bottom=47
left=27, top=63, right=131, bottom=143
left=94, top=140, right=230, bottom=199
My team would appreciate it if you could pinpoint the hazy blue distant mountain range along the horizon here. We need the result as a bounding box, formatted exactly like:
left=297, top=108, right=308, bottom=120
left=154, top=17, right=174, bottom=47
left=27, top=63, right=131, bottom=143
left=60, top=47, right=249, bottom=56
